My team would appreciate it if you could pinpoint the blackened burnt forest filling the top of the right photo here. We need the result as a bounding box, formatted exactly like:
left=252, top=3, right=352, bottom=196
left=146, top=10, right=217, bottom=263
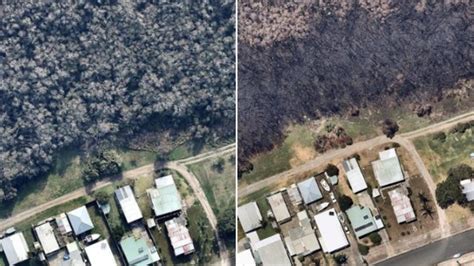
left=238, top=0, right=474, bottom=177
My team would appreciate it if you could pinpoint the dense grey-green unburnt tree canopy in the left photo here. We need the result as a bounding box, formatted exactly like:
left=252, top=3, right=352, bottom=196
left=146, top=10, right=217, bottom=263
left=0, top=0, right=235, bottom=200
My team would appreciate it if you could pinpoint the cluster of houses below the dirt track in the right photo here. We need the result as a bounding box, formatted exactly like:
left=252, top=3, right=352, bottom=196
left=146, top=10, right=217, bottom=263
left=238, top=149, right=416, bottom=265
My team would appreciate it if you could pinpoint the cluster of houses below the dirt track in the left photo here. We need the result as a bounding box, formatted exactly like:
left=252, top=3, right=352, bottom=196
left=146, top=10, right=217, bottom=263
left=0, top=175, right=195, bottom=266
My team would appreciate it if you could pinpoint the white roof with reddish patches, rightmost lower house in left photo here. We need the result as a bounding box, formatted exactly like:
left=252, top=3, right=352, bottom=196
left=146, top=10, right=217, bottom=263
left=165, top=217, right=194, bottom=256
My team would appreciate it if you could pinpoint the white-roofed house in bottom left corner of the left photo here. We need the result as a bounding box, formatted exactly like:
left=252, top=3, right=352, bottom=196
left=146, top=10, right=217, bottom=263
left=0, top=233, right=30, bottom=265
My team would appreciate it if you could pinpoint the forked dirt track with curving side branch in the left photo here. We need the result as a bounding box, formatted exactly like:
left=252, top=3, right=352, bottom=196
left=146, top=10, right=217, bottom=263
left=0, top=144, right=235, bottom=265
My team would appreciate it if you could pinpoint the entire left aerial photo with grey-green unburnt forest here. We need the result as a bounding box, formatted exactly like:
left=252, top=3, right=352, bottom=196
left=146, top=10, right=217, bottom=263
left=0, top=0, right=237, bottom=266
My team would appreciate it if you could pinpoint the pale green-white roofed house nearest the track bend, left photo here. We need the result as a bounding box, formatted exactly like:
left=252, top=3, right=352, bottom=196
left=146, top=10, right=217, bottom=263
left=148, top=175, right=182, bottom=217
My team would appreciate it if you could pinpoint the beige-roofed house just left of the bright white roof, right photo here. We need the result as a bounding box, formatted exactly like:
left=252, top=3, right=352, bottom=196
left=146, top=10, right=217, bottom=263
left=285, top=211, right=321, bottom=256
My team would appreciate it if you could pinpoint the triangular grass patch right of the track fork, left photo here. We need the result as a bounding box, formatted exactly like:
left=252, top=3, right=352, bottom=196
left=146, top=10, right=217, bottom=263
left=188, top=153, right=235, bottom=215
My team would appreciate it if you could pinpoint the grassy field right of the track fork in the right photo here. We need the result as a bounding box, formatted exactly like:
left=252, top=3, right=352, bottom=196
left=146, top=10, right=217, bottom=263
left=414, top=129, right=474, bottom=183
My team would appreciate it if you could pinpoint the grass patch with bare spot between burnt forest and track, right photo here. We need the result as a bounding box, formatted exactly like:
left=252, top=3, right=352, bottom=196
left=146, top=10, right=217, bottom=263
left=239, top=125, right=316, bottom=184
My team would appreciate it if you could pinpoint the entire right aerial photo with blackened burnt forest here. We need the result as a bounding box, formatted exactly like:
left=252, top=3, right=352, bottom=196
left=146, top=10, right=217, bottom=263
left=236, top=0, right=474, bottom=266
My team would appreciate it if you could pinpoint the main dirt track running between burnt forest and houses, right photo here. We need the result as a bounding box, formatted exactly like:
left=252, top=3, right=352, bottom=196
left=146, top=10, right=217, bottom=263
left=239, top=112, right=474, bottom=198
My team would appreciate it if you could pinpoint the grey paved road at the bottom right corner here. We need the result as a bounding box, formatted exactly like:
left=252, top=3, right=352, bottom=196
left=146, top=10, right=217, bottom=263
left=375, top=229, right=474, bottom=266
